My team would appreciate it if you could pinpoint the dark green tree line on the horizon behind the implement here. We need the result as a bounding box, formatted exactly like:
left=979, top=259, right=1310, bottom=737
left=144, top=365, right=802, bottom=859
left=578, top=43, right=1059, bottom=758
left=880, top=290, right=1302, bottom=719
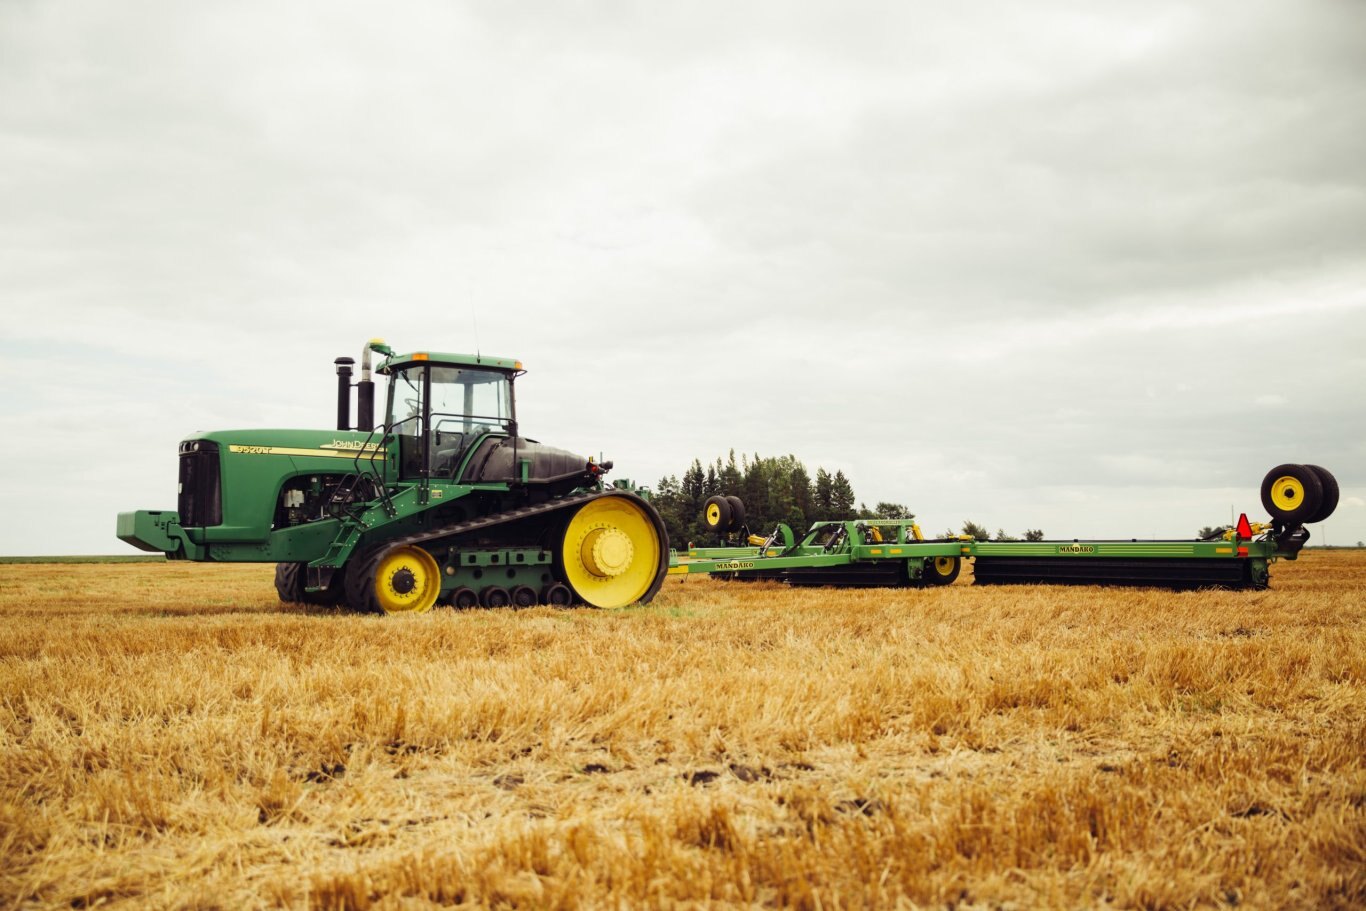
left=652, top=449, right=1044, bottom=549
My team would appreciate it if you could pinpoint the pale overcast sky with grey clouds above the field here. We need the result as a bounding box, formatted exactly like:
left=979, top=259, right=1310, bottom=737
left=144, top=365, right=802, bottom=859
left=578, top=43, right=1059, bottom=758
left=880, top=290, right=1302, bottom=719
left=0, top=0, right=1366, bottom=555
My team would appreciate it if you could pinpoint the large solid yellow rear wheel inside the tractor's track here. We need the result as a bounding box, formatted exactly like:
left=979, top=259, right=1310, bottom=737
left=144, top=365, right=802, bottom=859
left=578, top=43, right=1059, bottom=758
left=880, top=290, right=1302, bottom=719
left=560, top=497, right=663, bottom=608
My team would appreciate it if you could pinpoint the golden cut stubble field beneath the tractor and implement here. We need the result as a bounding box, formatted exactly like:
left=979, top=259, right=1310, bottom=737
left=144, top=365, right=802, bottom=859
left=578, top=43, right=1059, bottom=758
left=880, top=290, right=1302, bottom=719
left=0, top=552, right=1366, bottom=908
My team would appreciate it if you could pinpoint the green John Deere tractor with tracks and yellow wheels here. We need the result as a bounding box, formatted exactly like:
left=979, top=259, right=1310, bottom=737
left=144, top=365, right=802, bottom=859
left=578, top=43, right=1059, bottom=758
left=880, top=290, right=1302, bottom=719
left=117, top=340, right=669, bottom=613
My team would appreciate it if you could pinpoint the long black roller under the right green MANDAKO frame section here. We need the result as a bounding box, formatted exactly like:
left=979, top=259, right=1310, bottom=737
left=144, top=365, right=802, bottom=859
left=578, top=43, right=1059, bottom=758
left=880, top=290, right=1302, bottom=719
left=973, top=557, right=1255, bottom=589
